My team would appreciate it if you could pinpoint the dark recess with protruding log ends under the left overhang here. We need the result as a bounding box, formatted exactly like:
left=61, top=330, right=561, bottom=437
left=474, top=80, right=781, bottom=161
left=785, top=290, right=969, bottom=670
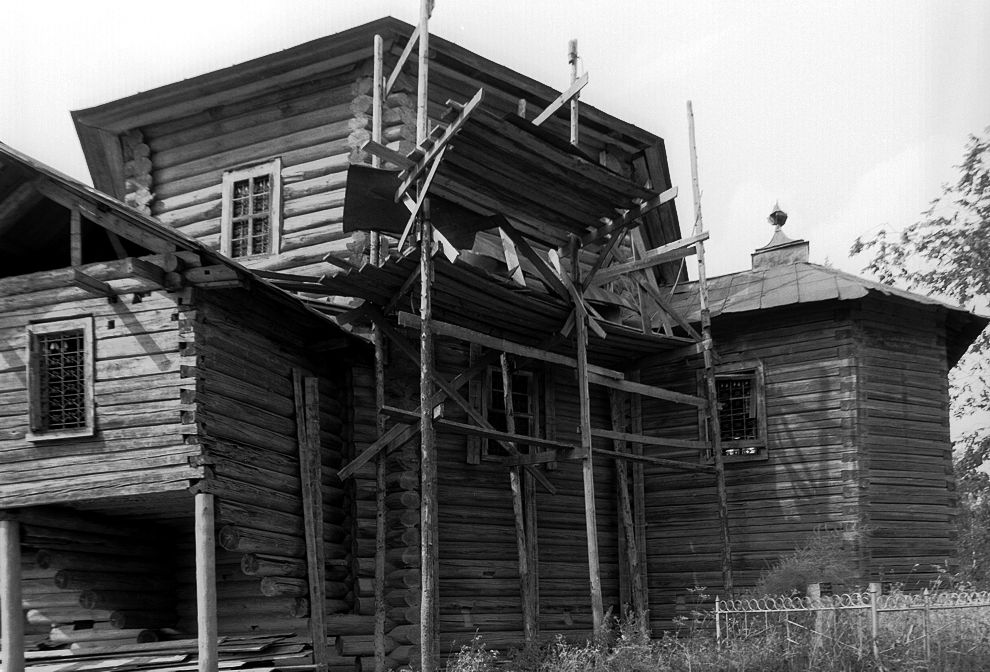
left=21, top=509, right=177, bottom=649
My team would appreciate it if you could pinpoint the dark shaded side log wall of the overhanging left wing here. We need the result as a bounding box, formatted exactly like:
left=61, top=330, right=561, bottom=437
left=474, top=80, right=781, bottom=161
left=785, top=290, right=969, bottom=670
left=182, top=291, right=356, bottom=632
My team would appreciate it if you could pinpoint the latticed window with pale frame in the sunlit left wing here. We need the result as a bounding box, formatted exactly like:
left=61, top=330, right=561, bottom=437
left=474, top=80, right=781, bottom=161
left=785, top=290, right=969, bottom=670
left=27, top=317, right=93, bottom=440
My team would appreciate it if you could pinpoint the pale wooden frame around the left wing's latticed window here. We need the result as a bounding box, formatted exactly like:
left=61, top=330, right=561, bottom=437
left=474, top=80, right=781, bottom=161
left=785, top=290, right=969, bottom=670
left=26, top=315, right=96, bottom=441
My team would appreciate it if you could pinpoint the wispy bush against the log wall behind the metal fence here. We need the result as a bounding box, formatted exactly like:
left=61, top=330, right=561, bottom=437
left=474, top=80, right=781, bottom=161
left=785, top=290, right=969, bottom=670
left=754, top=528, right=859, bottom=595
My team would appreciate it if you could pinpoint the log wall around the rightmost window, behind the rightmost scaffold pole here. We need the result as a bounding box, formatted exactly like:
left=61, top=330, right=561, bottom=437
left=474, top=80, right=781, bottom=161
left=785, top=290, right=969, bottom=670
left=642, top=303, right=861, bottom=629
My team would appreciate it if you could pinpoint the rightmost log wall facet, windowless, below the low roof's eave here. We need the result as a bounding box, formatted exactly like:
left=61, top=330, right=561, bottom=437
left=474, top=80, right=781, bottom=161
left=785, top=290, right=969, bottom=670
left=858, top=298, right=958, bottom=589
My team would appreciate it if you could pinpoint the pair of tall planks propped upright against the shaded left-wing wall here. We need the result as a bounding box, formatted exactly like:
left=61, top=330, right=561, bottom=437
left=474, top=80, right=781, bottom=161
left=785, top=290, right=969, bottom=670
left=292, top=369, right=330, bottom=672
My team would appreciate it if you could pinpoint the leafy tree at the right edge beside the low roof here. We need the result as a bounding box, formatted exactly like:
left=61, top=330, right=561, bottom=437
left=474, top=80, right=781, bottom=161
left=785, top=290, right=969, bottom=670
left=850, top=127, right=990, bottom=587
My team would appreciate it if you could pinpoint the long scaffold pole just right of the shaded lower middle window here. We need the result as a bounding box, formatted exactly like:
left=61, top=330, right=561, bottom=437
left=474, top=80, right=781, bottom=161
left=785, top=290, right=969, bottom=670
left=574, top=304, right=605, bottom=637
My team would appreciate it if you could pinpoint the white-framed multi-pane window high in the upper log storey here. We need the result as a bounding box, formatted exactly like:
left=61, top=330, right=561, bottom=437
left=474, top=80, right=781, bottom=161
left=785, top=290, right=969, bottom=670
left=220, top=159, right=282, bottom=258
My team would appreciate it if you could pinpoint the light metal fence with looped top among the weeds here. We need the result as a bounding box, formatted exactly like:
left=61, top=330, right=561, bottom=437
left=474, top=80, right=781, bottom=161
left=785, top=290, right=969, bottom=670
left=715, top=584, right=990, bottom=670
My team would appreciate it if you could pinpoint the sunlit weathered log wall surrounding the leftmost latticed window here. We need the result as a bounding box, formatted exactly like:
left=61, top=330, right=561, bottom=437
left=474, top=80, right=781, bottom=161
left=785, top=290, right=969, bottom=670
left=0, top=261, right=203, bottom=507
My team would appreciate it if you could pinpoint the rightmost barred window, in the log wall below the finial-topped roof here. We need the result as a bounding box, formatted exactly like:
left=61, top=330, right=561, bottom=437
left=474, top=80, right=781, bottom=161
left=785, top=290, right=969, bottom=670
left=715, top=362, right=767, bottom=461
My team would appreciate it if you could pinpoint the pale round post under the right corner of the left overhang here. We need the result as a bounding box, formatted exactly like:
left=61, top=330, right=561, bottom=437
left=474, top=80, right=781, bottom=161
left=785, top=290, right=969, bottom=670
left=194, top=492, right=219, bottom=672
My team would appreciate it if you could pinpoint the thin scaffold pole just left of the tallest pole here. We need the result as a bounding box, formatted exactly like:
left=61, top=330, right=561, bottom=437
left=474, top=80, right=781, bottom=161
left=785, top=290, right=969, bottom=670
left=370, top=35, right=388, bottom=672
